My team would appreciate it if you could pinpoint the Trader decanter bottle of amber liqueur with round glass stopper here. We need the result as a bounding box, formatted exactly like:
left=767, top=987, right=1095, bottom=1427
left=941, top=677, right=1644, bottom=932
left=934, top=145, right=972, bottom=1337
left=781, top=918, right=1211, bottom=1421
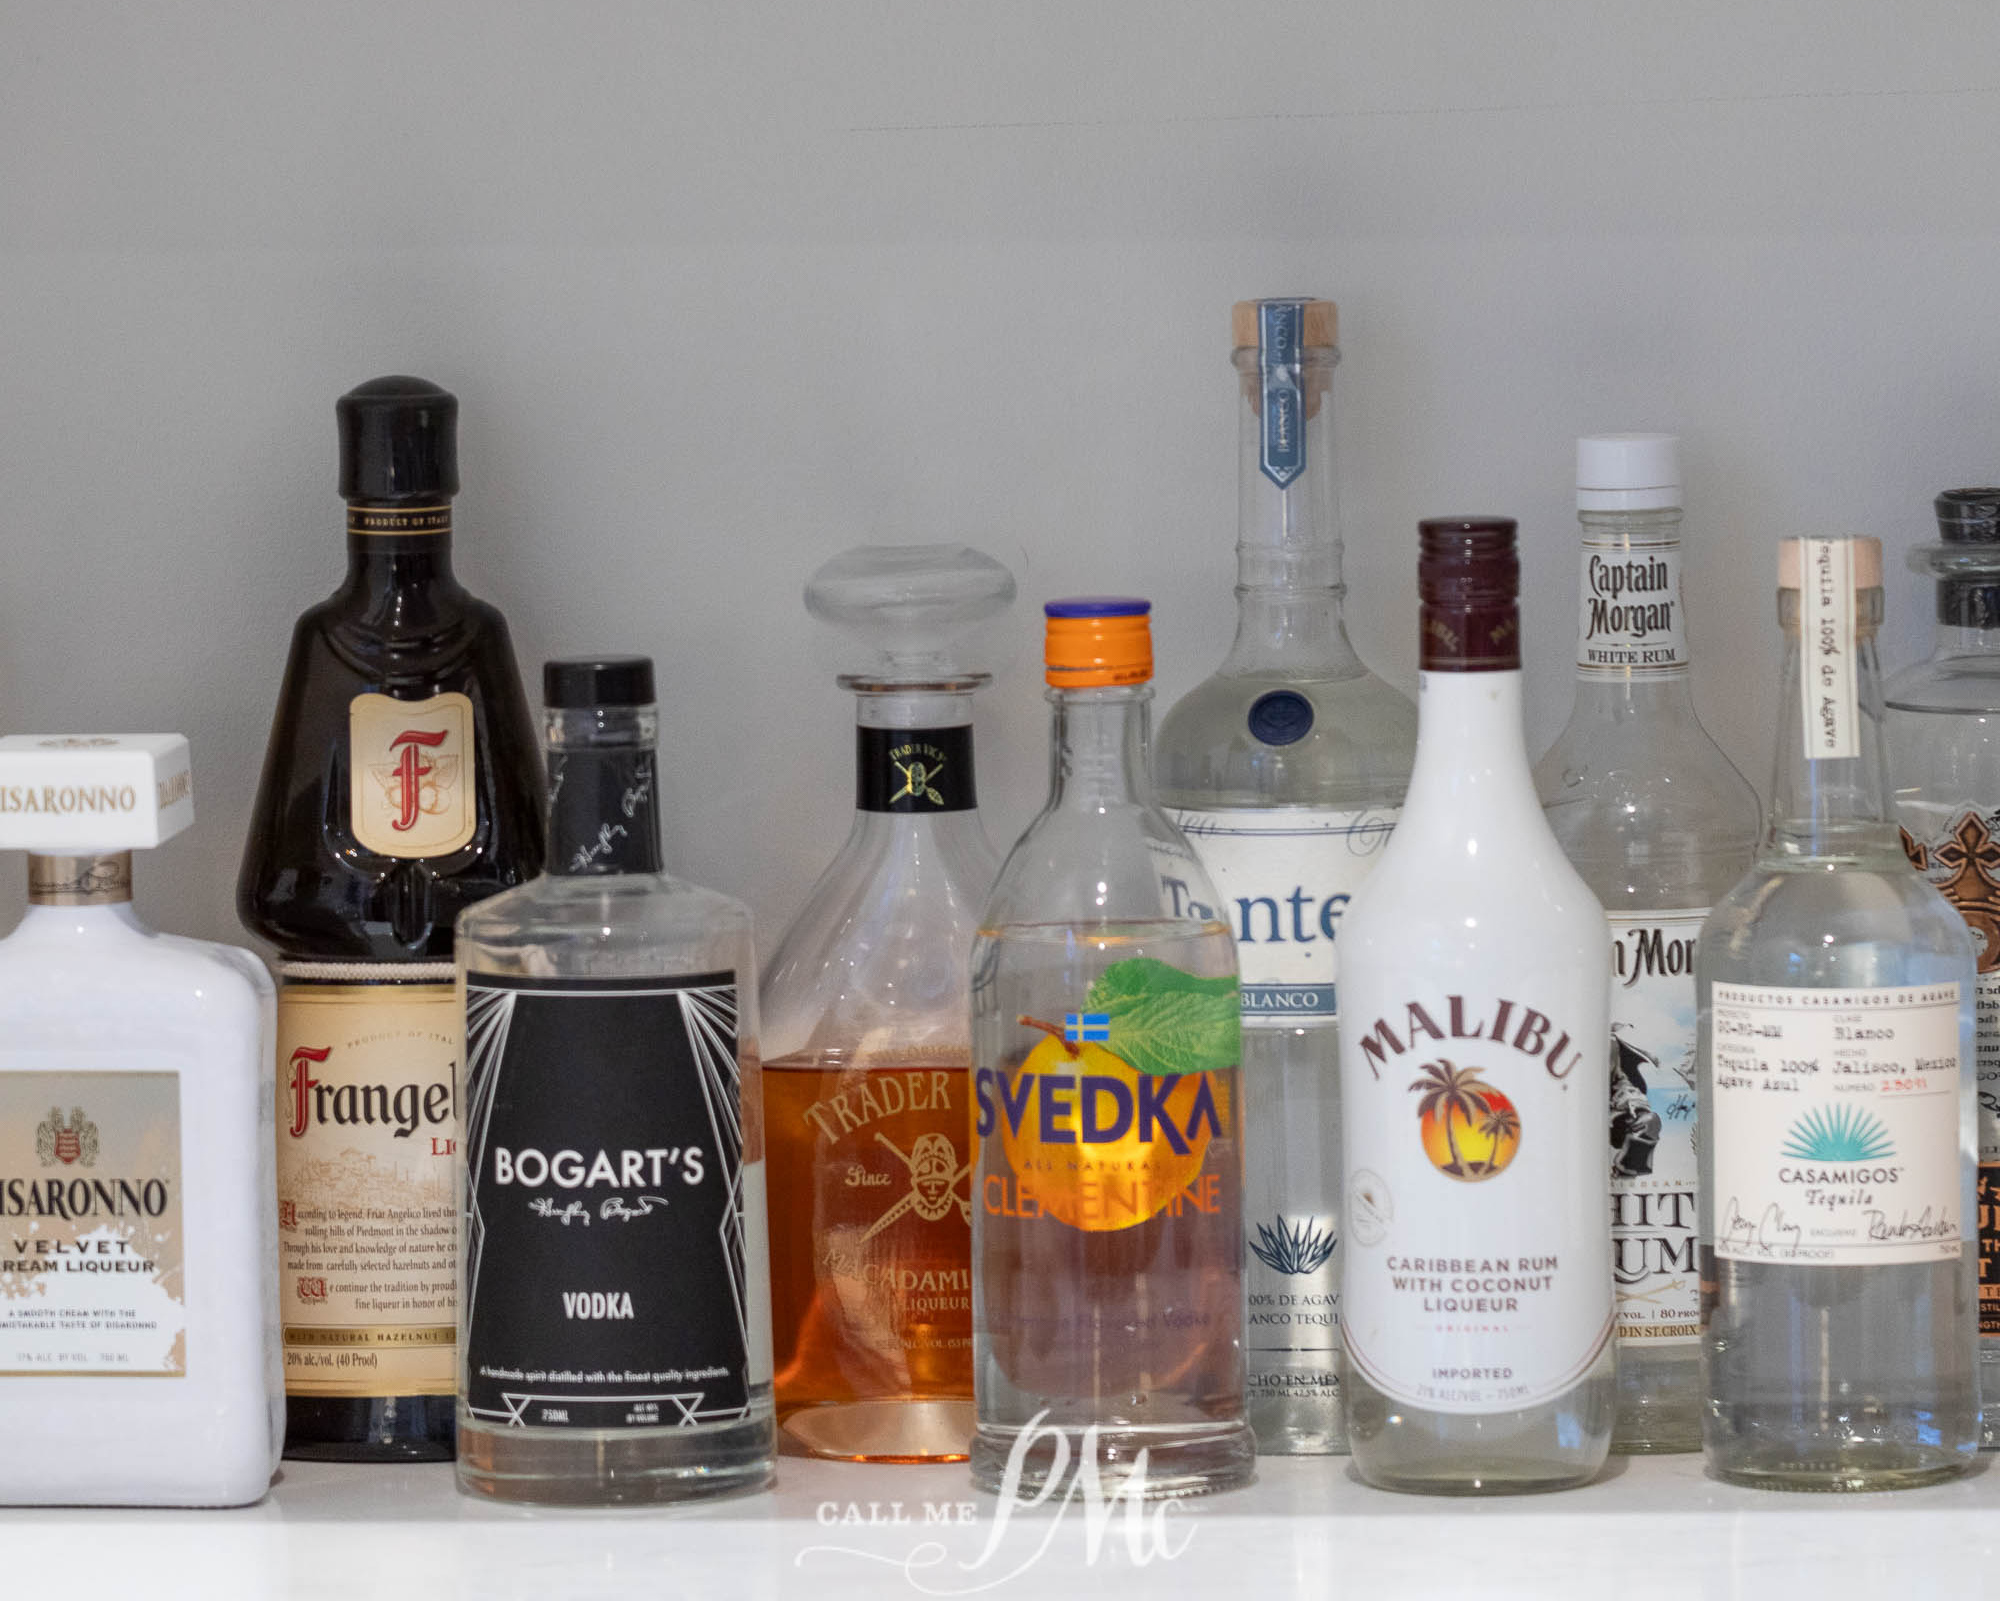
left=762, top=544, right=1014, bottom=1461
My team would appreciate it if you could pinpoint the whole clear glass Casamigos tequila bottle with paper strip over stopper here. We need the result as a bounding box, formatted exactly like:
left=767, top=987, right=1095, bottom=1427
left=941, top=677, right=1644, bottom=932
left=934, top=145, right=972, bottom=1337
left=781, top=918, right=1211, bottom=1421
left=1696, top=538, right=1980, bottom=1491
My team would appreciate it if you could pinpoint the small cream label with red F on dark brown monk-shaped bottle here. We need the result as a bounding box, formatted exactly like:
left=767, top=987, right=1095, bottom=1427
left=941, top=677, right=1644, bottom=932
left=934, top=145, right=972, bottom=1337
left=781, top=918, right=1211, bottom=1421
left=348, top=694, right=480, bottom=857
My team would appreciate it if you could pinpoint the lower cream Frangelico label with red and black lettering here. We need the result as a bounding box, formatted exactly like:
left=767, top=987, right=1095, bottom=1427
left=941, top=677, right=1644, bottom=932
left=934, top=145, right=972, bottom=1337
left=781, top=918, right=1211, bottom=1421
left=278, top=969, right=460, bottom=1395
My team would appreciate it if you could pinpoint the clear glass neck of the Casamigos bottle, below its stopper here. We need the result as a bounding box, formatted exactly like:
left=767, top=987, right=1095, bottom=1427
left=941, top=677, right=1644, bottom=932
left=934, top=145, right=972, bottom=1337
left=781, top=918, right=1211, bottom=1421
left=1764, top=588, right=1902, bottom=861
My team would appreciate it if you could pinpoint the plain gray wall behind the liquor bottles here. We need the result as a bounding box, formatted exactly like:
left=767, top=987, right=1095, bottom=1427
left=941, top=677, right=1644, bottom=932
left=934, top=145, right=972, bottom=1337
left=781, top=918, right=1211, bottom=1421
left=0, top=0, right=2000, bottom=949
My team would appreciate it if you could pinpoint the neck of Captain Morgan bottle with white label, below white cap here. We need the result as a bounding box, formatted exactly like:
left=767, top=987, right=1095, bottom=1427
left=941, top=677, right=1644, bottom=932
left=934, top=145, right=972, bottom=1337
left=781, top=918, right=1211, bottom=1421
left=1576, top=506, right=1694, bottom=712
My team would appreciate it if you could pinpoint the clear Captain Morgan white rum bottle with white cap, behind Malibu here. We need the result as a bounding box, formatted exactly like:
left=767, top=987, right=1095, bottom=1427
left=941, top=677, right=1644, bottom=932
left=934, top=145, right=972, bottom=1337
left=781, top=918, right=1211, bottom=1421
left=1534, top=434, right=1760, bottom=1451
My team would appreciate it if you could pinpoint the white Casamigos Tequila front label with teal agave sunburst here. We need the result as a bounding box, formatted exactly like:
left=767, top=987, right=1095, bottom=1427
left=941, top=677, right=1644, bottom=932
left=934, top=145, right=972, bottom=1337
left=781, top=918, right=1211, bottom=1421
left=1710, top=985, right=1970, bottom=1267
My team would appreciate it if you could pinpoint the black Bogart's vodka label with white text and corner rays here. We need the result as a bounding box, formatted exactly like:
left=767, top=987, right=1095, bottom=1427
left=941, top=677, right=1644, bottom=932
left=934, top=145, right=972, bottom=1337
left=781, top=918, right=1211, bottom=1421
left=464, top=973, right=752, bottom=1429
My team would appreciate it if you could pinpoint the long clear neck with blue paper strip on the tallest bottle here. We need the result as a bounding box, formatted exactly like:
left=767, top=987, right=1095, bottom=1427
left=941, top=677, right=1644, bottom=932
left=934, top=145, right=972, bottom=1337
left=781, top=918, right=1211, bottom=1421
left=1228, top=346, right=1356, bottom=672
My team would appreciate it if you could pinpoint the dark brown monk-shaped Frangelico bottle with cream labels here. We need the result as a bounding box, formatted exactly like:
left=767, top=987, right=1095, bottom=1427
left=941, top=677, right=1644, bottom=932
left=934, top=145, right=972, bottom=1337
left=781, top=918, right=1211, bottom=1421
left=236, top=378, right=542, bottom=1461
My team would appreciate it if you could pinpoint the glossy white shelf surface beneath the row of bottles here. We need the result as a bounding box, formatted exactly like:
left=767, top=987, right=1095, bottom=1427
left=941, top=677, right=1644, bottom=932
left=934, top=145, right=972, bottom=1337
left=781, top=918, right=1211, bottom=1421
left=0, top=1441, right=2000, bottom=1601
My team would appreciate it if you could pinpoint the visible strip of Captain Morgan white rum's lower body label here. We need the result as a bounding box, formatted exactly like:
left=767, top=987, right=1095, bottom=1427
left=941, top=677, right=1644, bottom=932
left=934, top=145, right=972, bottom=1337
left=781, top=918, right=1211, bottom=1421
left=1610, top=907, right=1708, bottom=1341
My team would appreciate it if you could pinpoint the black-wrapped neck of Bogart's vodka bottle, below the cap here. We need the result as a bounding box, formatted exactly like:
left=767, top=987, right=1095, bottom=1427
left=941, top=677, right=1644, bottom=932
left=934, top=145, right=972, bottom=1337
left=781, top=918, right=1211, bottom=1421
left=544, top=706, right=664, bottom=879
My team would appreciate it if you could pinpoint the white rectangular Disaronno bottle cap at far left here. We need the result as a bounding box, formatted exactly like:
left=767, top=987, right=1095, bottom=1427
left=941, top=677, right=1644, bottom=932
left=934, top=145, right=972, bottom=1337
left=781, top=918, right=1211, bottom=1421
left=0, top=734, right=194, bottom=857
